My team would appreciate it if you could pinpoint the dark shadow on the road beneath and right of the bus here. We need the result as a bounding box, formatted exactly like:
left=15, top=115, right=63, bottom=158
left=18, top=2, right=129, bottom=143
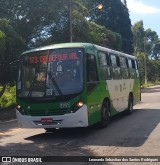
left=23, top=109, right=160, bottom=147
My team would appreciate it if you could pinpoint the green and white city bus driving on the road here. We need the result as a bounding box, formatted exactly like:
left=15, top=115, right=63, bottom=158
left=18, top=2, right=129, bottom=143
left=16, top=43, right=141, bottom=130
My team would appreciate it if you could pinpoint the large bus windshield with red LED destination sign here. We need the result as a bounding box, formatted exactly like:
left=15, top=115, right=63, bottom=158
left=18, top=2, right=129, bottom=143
left=17, top=48, right=83, bottom=97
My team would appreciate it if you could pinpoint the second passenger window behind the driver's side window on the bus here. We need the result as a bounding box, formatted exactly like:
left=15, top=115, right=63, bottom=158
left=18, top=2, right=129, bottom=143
left=110, top=54, right=121, bottom=79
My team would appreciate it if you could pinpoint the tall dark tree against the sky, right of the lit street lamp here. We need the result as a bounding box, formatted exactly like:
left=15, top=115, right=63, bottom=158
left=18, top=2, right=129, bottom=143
left=89, top=0, right=133, bottom=54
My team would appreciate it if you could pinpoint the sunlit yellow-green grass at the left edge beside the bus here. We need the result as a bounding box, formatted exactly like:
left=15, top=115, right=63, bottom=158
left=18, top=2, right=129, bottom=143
left=0, top=86, right=16, bottom=109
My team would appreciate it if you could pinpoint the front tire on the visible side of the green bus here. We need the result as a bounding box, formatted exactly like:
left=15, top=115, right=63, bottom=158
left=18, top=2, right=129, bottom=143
left=100, top=101, right=110, bottom=128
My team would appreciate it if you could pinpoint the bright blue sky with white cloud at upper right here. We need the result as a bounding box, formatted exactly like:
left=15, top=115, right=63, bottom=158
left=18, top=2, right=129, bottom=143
left=127, top=0, right=160, bottom=38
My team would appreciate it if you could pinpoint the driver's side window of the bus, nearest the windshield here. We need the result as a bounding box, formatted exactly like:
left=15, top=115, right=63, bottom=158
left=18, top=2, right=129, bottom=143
left=87, top=54, right=98, bottom=82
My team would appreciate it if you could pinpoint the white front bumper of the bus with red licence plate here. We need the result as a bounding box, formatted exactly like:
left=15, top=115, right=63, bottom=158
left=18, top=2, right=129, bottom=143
left=16, top=105, right=88, bottom=128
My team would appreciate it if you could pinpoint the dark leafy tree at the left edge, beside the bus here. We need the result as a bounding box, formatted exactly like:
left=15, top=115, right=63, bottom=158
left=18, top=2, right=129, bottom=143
left=0, top=19, right=23, bottom=97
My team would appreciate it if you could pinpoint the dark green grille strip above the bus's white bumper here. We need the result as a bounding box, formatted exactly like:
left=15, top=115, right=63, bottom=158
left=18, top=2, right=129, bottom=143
left=28, top=109, right=67, bottom=116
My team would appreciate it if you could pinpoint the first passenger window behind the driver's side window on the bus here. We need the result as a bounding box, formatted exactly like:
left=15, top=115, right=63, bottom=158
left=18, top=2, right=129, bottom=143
left=98, top=52, right=111, bottom=80
